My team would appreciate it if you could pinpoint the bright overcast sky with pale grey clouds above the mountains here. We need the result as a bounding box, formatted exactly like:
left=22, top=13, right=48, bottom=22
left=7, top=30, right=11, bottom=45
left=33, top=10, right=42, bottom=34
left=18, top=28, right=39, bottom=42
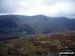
left=0, top=0, right=75, bottom=17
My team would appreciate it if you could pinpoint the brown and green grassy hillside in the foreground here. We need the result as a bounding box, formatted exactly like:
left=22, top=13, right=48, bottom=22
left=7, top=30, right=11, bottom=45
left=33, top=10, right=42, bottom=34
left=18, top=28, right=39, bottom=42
left=0, top=34, right=75, bottom=56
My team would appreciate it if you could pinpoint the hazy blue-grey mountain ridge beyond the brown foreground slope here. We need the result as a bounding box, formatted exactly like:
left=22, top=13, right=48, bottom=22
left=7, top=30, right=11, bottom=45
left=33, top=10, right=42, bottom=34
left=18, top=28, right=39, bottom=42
left=0, top=15, right=75, bottom=37
